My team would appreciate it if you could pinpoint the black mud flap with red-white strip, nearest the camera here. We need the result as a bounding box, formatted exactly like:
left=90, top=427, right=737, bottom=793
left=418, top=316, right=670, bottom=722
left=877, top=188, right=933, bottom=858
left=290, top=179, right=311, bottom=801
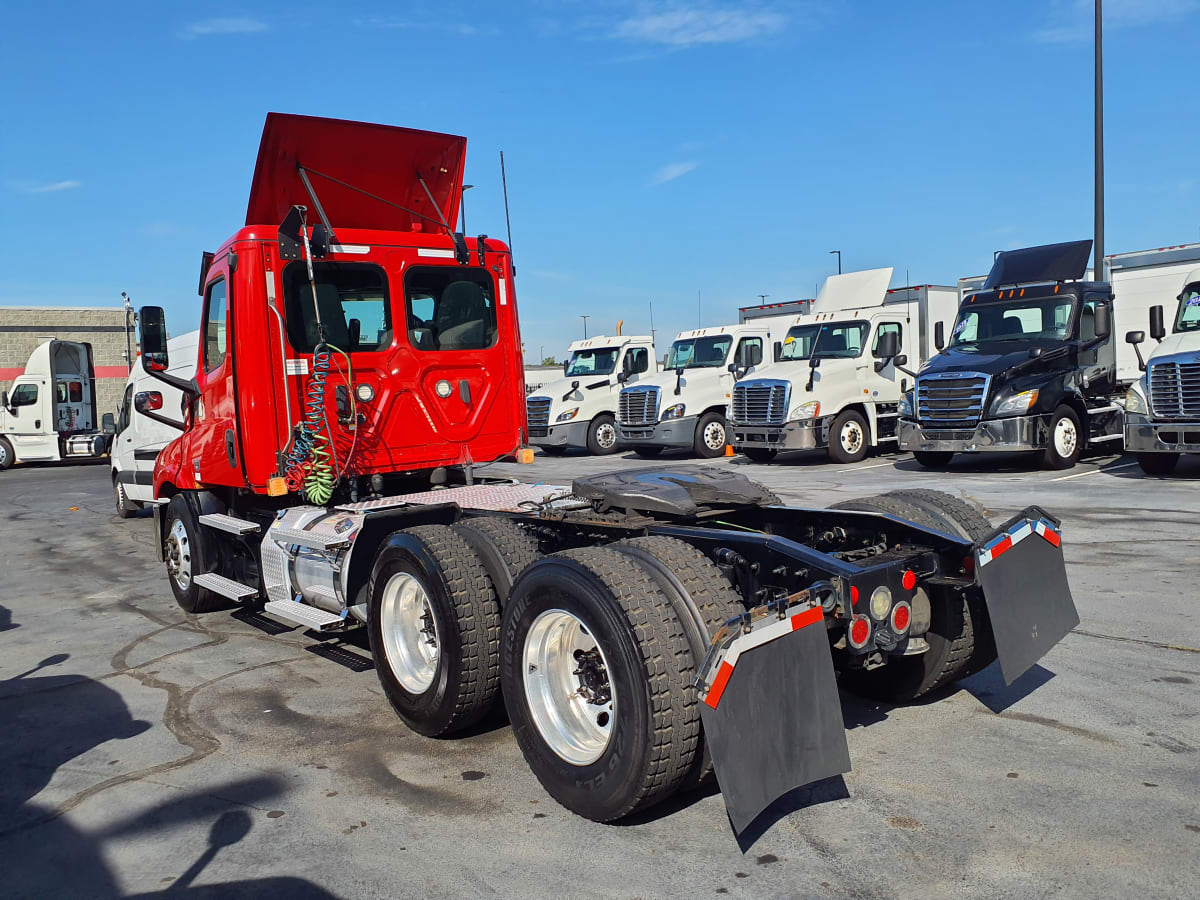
left=698, top=601, right=850, bottom=834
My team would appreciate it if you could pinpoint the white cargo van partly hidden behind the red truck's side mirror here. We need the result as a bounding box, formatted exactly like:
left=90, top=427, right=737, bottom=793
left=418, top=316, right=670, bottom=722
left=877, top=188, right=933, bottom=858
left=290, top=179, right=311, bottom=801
left=109, top=331, right=200, bottom=518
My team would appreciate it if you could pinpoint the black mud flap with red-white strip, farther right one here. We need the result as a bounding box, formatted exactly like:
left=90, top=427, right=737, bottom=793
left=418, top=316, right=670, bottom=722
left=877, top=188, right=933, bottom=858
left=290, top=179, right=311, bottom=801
left=976, top=506, right=1079, bottom=684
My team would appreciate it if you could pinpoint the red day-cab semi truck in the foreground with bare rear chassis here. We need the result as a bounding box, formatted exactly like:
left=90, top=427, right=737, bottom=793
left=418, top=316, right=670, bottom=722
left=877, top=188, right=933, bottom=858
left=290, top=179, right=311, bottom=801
left=139, top=114, right=1078, bottom=830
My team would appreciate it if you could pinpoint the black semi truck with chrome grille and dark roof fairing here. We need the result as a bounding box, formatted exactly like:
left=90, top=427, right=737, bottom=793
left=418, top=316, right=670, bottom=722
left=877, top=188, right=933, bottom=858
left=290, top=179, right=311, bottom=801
left=900, top=240, right=1128, bottom=469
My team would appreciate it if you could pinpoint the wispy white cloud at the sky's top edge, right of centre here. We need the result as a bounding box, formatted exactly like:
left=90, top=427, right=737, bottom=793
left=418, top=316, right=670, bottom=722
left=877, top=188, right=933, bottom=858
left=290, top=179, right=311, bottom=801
left=612, top=2, right=787, bottom=49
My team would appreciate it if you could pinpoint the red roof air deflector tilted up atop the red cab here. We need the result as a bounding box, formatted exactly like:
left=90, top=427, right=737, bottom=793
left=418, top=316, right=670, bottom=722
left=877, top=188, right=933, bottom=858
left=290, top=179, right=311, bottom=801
left=246, top=113, right=467, bottom=233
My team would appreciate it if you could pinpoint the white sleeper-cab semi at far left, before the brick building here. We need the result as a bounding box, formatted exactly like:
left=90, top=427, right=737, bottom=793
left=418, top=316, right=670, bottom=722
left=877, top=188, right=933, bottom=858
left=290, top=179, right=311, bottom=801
left=0, top=341, right=110, bottom=472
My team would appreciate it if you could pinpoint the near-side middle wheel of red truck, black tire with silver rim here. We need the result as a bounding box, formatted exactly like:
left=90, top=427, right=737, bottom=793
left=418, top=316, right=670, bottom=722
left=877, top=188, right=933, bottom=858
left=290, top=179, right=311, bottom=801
left=367, top=524, right=500, bottom=737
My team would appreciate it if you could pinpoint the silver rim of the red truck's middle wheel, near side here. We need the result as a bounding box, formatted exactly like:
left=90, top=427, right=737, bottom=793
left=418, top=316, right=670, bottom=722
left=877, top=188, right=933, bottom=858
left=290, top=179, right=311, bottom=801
left=379, top=572, right=440, bottom=694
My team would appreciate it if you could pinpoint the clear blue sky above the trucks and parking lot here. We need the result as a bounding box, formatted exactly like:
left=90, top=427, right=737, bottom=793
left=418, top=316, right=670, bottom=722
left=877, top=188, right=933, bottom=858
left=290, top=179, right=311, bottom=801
left=0, top=0, right=1200, bottom=358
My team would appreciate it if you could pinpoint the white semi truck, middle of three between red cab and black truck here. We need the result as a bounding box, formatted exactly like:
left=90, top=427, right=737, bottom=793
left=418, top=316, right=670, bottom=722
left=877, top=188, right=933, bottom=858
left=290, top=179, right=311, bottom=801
left=617, top=317, right=777, bottom=457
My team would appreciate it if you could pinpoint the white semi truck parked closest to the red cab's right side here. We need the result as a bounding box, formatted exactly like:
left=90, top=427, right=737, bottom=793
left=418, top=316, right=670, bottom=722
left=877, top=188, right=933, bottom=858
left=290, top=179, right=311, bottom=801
left=526, top=333, right=659, bottom=456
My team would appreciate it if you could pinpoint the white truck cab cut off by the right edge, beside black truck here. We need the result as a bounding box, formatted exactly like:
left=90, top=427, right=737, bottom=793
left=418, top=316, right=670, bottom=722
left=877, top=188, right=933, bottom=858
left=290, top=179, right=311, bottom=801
left=1124, top=268, right=1200, bottom=475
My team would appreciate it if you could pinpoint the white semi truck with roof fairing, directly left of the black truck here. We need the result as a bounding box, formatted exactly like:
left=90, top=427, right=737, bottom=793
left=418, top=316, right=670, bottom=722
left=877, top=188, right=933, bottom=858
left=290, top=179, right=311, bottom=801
left=730, top=269, right=958, bottom=463
